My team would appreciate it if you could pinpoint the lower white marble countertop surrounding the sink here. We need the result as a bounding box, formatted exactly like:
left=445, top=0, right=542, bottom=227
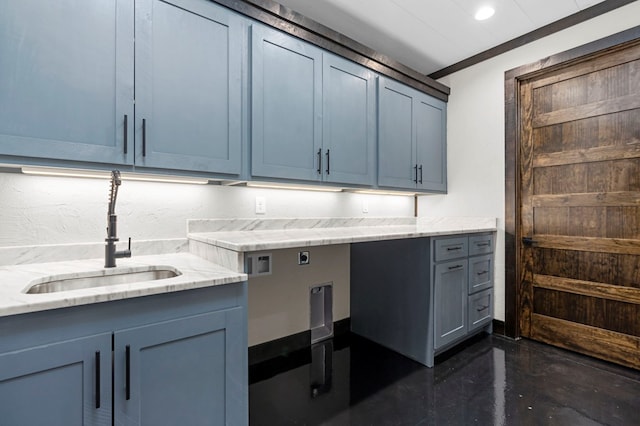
left=0, top=253, right=247, bottom=316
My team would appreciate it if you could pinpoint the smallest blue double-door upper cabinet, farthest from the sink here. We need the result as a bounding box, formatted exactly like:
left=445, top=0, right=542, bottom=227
left=378, top=77, right=447, bottom=192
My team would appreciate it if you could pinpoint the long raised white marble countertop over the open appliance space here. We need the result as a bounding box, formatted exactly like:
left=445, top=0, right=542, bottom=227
left=188, top=218, right=496, bottom=252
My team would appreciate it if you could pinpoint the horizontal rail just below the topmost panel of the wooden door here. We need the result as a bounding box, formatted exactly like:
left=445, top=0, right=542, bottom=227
left=533, top=94, right=640, bottom=128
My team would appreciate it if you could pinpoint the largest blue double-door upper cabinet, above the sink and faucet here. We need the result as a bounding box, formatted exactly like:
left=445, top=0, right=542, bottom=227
left=0, top=0, right=244, bottom=175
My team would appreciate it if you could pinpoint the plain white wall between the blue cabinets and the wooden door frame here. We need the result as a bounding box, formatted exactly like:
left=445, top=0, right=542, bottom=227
left=418, top=1, right=640, bottom=320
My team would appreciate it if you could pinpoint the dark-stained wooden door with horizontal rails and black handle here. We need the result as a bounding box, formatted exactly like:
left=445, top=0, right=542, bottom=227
left=520, top=45, right=640, bottom=368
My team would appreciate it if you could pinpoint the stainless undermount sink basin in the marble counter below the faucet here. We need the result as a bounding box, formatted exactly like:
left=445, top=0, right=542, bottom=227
left=25, top=266, right=182, bottom=294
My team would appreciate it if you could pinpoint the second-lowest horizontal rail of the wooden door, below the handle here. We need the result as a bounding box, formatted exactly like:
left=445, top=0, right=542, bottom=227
left=533, top=274, right=640, bottom=305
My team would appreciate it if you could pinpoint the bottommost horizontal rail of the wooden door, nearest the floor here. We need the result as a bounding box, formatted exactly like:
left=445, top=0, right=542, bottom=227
left=531, top=314, right=640, bottom=368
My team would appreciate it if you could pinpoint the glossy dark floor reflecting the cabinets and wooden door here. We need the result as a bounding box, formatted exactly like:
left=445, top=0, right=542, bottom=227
left=249, top=335, right=640, bottom=426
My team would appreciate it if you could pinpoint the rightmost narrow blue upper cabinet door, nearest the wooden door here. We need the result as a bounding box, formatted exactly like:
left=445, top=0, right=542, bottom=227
left=415, top=94, right=447, bottom=192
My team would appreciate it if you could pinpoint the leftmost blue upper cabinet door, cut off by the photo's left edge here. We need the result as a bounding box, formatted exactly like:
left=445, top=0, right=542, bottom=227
left=0, top=0, right=133, bottom=164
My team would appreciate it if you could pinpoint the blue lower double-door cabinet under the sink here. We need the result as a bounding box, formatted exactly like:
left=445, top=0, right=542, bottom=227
left=0, top=283, right=248, bottom=426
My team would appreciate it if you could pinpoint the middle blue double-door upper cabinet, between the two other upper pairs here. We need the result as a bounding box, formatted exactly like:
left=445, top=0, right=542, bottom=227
left=251, top=25, right=376, bottom=185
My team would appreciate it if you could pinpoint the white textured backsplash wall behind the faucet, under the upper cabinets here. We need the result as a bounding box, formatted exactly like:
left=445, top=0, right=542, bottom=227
left=0, top=173, right=413, bottom=247
